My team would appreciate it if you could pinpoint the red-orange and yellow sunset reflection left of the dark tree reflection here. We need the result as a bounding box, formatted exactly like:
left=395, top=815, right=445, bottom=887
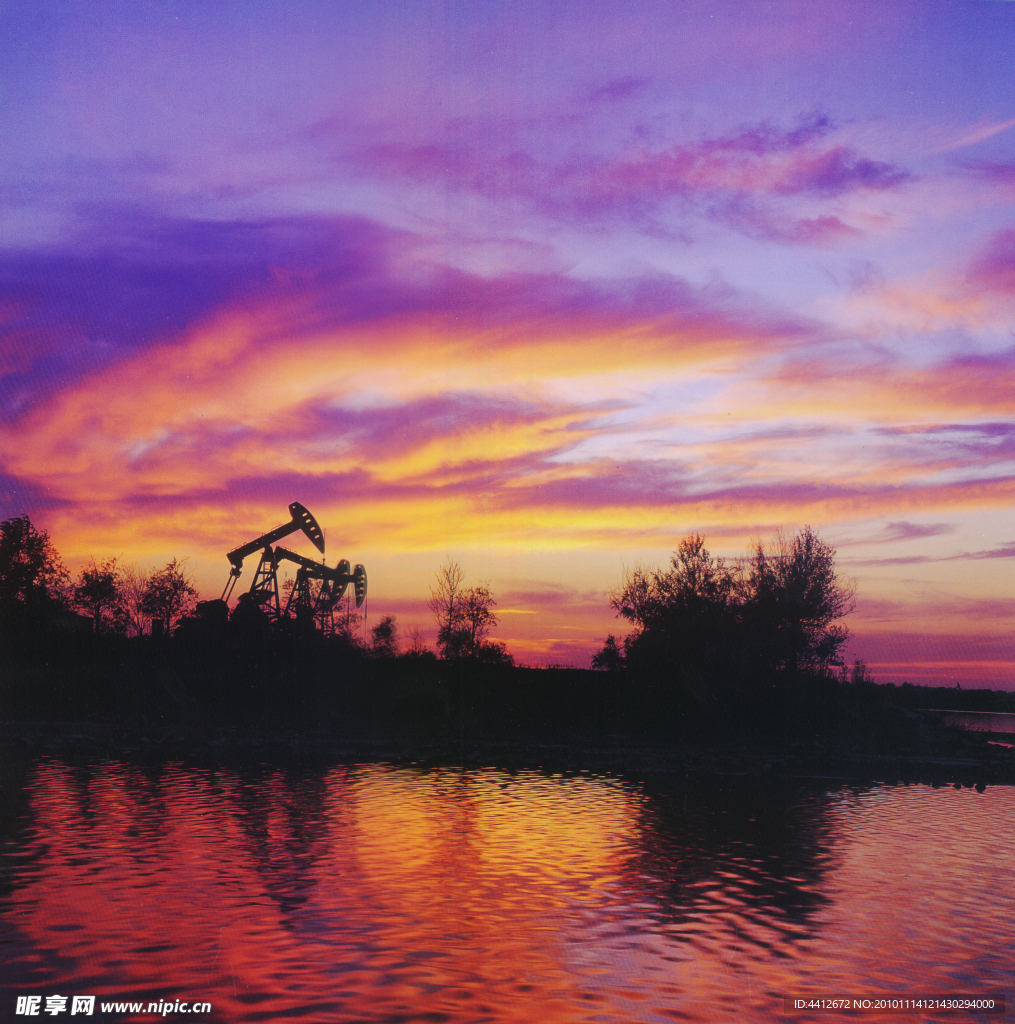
left=1, top=765, right=636, bottom=1021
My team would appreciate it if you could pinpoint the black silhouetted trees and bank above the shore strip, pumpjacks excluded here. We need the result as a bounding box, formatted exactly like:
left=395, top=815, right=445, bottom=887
left=0, top=516, right=1015, bottom=774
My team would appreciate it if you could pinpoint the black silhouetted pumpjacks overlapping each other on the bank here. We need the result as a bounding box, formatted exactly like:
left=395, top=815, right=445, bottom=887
left=222, top=502, right=367, bottom=633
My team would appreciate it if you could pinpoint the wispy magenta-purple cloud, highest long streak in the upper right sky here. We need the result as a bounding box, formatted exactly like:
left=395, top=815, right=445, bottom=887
left=351, top=113, right=914, bottom=245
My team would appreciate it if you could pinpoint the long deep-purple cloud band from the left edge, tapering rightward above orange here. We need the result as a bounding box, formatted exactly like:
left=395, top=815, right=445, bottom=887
left=0, top=210, right=815, bottom=430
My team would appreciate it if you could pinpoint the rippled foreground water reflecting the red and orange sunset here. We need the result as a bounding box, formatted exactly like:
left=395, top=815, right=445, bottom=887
left=0, top=760, right=1015, bottom=1024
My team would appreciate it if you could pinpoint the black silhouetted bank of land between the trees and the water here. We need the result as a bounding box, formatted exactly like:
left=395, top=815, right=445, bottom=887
left=0, top=635, right=1015, bottom=786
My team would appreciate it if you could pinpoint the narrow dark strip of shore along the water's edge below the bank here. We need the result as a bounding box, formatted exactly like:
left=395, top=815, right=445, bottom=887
left=0, top=721, right=1015, bottom=792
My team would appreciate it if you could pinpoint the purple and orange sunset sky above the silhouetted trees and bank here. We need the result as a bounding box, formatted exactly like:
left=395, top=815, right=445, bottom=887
left=0, top=0, right=1015, bottom=689
